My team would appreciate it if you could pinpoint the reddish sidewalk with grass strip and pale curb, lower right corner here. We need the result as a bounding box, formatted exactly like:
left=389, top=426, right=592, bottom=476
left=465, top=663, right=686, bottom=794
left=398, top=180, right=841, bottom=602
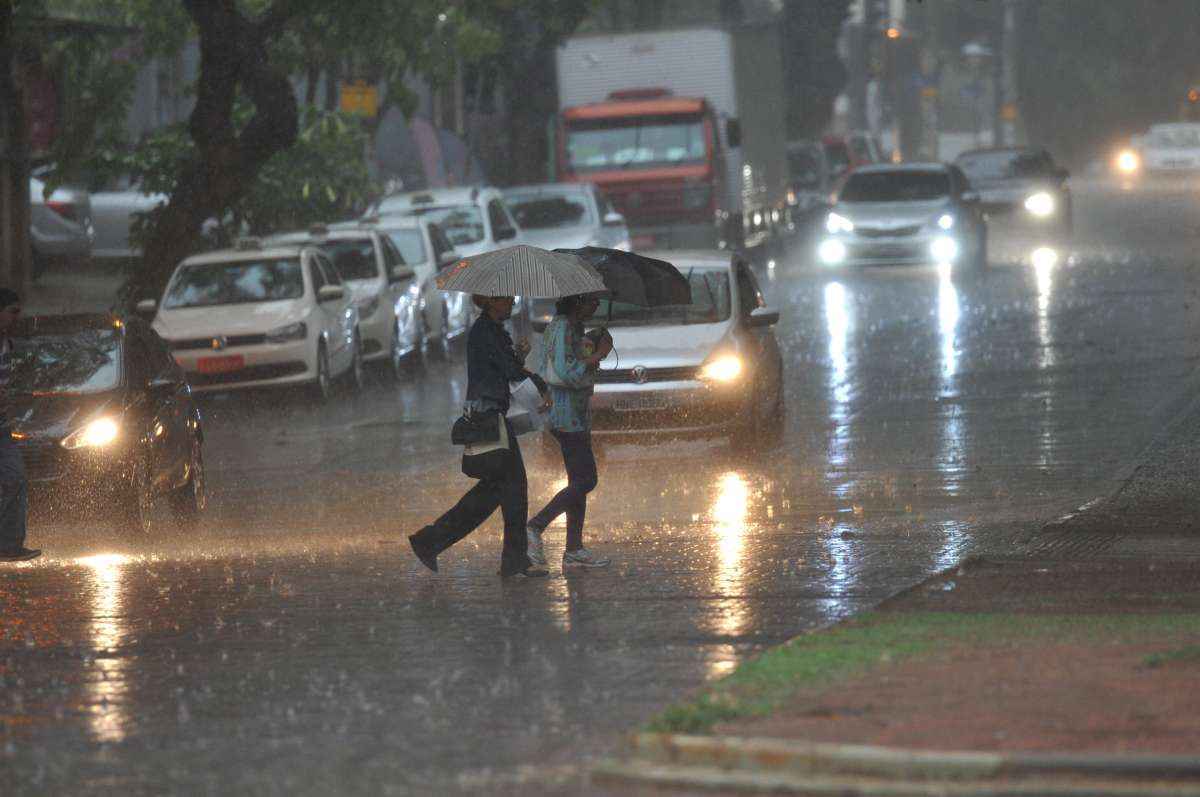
left=593, top=384, right=1200, bottom=795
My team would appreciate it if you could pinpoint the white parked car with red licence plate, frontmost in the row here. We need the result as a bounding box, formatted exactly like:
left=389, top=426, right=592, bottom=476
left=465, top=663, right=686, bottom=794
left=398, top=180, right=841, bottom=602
left=138, top=239, right=362, bottom=401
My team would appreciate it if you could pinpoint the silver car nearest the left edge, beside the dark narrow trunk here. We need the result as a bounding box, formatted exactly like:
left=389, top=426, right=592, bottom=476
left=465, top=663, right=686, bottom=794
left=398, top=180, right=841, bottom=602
left=29, top=178, right=96, bottom=278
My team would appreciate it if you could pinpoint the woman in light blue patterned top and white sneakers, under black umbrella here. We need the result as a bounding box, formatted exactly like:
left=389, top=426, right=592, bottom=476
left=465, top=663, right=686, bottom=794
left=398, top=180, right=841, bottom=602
left=527, top=296, right=612, bottom=569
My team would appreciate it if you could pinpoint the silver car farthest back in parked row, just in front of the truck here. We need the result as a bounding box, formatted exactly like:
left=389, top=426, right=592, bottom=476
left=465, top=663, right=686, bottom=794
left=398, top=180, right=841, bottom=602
left=504, top=182, right=630, bottom=250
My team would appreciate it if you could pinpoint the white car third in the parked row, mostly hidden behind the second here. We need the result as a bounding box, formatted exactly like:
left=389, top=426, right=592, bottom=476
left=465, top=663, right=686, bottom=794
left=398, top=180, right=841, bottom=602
left=345, top=216, right=467, bottom=347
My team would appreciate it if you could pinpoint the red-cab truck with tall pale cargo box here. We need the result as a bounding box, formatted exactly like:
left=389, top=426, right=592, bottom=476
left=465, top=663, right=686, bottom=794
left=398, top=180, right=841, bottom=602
left=550, top=25, right=787, bottom=248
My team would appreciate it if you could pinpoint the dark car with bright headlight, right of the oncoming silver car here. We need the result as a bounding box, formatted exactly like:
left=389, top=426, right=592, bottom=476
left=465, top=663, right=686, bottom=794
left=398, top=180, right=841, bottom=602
left=954, top=146, right=1073, bottom=232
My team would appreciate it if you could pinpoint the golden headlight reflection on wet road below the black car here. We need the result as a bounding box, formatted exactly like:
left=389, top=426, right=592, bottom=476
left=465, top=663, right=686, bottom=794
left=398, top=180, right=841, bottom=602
left=74, top=553, right=131, bottom=742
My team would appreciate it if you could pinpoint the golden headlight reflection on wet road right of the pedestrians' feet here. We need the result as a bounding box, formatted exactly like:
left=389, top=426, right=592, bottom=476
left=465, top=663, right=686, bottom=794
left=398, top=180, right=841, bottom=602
left=708, top=471, right=750, bottom=677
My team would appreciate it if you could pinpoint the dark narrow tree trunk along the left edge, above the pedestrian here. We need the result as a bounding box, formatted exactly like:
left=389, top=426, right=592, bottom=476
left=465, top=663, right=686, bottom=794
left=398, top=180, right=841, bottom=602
left=0, top=2, right=32, bottom=296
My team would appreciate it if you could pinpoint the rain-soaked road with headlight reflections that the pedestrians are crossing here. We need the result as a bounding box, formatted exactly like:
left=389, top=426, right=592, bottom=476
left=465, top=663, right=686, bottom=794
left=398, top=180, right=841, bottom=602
left=0, top=177, right=1200, bottom=795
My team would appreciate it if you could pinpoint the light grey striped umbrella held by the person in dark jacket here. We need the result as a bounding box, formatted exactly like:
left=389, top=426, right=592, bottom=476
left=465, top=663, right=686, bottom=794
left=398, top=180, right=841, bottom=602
left=437, top=245, right=606, bottom=299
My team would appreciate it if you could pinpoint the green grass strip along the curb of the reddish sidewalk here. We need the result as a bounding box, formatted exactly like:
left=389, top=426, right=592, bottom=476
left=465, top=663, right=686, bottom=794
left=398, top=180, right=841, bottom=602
left=647, top=612, right=1200, bottom=733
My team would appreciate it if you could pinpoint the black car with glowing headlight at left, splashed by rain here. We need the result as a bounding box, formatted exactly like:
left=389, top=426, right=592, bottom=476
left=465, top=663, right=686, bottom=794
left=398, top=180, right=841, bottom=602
left=8, top=314, right=206, bottom=532
